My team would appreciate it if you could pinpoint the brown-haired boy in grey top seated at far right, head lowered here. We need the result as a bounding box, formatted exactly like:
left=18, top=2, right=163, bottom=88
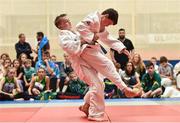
left=159, top=56, right=173, bottom=87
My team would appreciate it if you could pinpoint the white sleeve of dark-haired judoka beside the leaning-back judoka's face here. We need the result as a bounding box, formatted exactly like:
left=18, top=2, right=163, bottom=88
left=76, top=13, right=99, bottom=43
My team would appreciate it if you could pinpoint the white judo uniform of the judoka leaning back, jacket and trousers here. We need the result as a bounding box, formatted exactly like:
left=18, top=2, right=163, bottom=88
left=59, top=30, right=105, bottom=117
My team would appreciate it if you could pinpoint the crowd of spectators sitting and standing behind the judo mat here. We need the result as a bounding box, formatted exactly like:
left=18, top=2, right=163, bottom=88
left=0, top=28, right=180, bottom=100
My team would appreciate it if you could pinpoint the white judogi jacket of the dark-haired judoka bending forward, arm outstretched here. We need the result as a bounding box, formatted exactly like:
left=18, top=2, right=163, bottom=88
left=76, top=12, right=125, bottom=53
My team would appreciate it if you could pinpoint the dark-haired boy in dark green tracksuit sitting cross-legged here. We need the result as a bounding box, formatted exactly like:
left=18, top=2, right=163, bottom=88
left=141, top=62, right=163, bottom=98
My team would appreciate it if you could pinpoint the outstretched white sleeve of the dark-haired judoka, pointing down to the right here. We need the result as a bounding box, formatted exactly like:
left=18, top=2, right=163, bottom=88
left=97, top=30, right=126, bottom=53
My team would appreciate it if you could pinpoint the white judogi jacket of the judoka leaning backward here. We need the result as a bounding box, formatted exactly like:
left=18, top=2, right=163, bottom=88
left=59, top=30, right=90, bottom=80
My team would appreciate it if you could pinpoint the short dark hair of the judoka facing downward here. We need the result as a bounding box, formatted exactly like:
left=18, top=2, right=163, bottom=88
left=102, top=8, right=119, bottom=25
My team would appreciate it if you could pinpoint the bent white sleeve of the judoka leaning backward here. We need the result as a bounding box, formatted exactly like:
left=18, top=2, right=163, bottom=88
left=59, top=32, right=81, bottom=54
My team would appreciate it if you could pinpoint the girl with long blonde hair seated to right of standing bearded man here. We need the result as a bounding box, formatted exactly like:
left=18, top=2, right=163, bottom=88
left=132, top=53, right=146, bottom=80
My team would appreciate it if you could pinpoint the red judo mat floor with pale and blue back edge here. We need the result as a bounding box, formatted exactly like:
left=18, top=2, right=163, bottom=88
left=0, top=98, right=180, bottom=123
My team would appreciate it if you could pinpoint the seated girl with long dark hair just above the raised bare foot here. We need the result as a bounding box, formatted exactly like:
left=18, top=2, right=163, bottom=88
left=120, top=62, right=142, bottom=97
